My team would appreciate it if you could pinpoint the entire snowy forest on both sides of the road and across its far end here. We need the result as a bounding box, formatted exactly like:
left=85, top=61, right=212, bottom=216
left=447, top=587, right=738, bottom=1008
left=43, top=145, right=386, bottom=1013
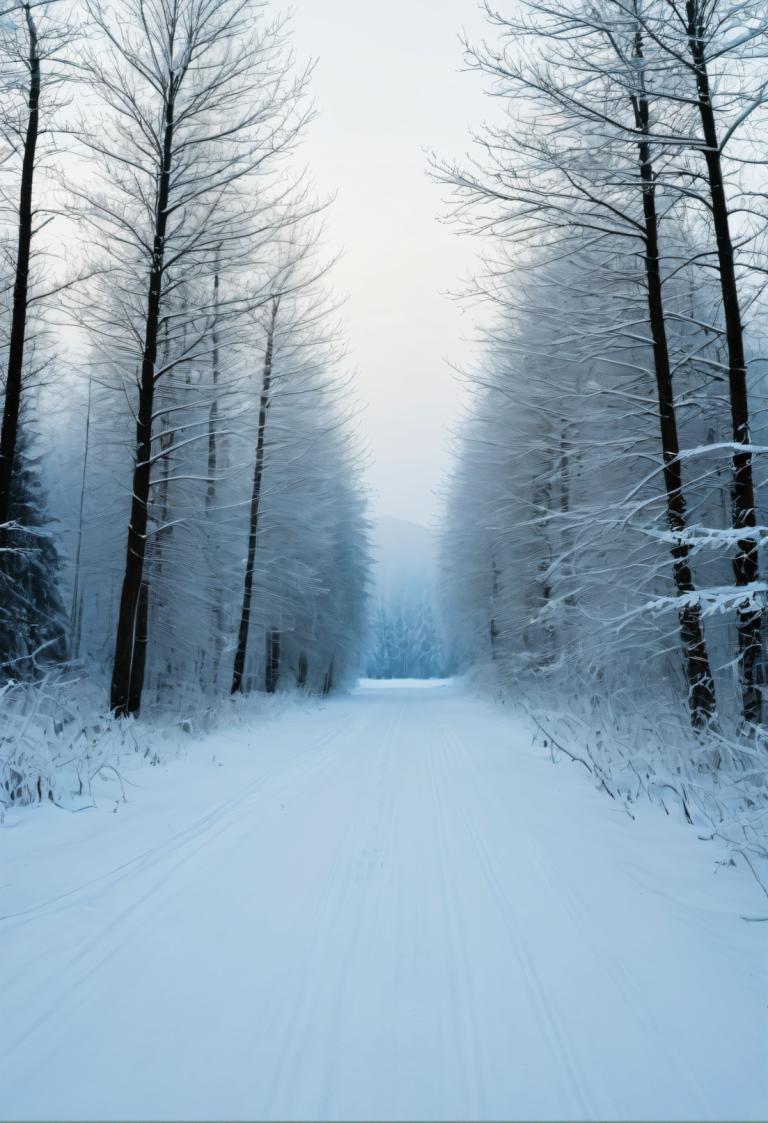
left=0, top=0, right=768, bottom=893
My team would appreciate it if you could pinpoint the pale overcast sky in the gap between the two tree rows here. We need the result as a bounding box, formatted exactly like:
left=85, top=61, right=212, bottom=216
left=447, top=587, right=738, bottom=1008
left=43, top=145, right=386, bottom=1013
left=292, top=0, right=487, bottom=523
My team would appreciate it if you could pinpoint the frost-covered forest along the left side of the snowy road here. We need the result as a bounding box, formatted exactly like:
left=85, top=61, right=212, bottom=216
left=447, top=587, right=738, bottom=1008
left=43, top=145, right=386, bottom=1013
left=0, top=0, right=368, bottom=802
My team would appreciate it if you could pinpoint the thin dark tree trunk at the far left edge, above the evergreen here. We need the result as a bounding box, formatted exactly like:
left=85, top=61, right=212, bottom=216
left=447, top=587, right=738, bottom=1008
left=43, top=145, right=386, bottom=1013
left=0, top=4, right=40, bottom=527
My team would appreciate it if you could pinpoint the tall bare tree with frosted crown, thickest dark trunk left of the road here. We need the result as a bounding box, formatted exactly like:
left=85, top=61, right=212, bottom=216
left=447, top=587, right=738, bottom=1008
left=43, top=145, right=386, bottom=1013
left=83, top=0, right=314, bottom=715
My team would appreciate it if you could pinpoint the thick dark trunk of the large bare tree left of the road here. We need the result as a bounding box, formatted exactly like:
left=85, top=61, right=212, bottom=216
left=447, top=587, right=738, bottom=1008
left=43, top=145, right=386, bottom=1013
left=110, top=87, right=174, bottom=716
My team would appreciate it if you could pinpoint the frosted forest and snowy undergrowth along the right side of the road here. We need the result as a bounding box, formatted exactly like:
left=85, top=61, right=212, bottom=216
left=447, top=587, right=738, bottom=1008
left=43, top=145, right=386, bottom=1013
left=432, top=0, right=768, bottom=880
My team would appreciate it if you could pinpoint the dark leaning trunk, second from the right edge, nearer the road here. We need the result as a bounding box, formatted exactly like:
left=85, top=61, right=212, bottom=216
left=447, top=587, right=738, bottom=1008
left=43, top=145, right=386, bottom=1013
left=632, top=29, right=716, bottom=730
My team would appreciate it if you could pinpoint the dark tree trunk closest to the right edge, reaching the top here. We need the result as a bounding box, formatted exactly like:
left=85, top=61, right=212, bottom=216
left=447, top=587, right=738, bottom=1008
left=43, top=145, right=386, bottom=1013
left=686, top=0, right=762, bottom=722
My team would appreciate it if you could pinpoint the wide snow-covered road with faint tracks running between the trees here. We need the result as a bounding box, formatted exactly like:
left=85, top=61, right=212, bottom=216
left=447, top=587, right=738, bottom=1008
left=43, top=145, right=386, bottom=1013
left=0, top=686, right=768, bottom=1120
